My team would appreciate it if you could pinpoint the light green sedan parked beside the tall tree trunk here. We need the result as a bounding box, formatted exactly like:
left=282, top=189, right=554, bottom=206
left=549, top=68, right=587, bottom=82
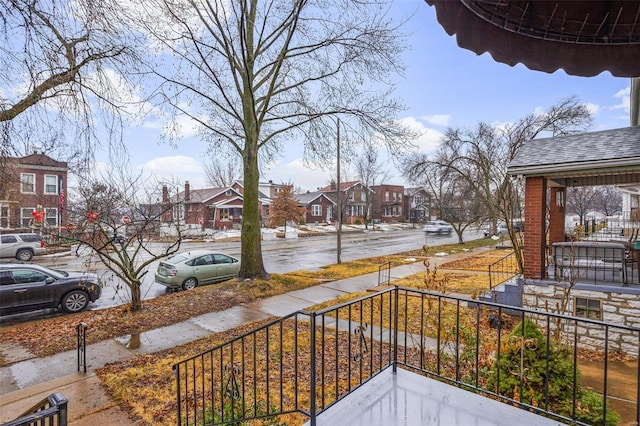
left=155, top=250, right=240, bottom=290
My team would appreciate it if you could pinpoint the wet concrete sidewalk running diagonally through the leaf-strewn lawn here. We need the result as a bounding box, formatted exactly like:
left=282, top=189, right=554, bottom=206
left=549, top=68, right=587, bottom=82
left=0, top=248, right=489, bottom=425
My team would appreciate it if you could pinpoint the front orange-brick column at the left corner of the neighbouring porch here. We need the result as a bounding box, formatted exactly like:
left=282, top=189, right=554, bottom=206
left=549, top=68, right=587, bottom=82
left=524, top=177, right=547, bottom=279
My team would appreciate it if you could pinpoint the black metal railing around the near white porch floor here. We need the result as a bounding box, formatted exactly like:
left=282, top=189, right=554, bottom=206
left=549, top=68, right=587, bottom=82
left=173, top=287, right=640, bottom=426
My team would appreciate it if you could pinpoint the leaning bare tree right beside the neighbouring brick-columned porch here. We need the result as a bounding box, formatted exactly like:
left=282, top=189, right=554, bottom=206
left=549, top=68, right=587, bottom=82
left=405, top=97, right=592, bottom=271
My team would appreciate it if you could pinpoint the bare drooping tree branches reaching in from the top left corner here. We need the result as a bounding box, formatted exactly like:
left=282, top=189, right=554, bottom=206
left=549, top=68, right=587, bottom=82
left=0, top=0, right=132, bottom=174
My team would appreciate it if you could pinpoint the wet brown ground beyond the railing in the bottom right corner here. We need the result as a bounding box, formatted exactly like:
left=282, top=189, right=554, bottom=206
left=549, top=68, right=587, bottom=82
left=578, top=361, right=638, bottom=426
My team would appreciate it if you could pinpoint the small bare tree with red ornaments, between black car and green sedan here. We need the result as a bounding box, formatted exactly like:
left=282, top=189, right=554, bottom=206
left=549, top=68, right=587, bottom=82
left=69, top=171, right=181, bottom=310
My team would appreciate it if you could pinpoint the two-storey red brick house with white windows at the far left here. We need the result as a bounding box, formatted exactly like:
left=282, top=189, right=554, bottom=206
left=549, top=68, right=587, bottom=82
left=0, top=151, right=68, bottom=233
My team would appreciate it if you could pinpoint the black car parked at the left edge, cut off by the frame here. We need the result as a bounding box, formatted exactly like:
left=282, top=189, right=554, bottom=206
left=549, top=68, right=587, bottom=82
left=0, top=263, right=102, bottom=315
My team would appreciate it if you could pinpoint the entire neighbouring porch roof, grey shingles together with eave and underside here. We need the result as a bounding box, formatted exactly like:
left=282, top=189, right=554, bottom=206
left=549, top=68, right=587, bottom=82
left=507, top=127, right=640, bottom=187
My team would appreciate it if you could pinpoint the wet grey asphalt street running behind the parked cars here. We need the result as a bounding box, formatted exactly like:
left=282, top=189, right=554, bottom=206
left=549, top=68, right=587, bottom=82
left=7, top=228, right=482, bottom=316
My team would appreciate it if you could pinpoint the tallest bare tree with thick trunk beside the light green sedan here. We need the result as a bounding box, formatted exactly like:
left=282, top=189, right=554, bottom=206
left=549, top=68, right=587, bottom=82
left=132, top=0, right=412, bottom=279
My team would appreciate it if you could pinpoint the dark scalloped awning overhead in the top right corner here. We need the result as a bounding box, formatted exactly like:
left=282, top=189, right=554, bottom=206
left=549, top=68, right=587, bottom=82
left=426, top=0, right=640, bottom=77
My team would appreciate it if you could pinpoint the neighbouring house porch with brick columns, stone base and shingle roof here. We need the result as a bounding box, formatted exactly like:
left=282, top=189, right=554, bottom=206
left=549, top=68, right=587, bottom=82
left=508, top=126, right=640, bottom=352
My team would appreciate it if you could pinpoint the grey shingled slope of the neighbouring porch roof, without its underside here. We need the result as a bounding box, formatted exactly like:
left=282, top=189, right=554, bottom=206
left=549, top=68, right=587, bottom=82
left=508, top=127, right=640, bottom=175
